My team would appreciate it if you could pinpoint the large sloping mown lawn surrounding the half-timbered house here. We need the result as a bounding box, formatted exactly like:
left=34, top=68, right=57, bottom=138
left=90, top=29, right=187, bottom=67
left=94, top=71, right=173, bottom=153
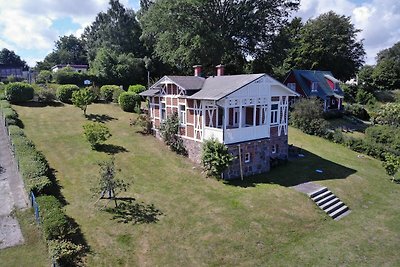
left=15, top=104, right=400, bottom=266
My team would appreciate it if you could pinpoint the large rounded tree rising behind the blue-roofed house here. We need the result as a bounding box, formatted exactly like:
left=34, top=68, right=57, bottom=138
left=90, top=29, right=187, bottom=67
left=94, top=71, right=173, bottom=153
left=286, top=11, right=365, bottom=81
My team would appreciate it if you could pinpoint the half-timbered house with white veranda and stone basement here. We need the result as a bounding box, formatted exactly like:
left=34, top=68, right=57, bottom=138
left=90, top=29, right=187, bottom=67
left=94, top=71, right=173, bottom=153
left=141, top=65, right=298, bottom=179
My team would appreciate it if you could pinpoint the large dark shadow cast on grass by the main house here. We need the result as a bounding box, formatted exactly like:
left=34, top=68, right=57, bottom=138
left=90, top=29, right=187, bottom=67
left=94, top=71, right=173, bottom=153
left=224, top=149, right=356, bottom=187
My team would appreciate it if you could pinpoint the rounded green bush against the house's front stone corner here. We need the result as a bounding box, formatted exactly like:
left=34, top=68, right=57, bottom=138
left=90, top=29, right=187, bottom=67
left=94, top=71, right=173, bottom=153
left=201, top=139, right=234, bottom=177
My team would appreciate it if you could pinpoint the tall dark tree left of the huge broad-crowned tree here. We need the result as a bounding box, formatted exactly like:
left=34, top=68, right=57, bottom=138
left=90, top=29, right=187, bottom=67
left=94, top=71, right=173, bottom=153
left=82, top=0, right=144, bottom=63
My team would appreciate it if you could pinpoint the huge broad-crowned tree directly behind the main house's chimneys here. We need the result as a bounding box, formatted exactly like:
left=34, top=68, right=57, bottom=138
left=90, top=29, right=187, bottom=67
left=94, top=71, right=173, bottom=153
left=140, top=0, right=299, bottom=73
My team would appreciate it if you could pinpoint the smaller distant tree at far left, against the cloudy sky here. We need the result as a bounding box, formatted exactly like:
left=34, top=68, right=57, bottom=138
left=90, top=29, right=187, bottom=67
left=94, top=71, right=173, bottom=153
left=36, top=34, right=88, bottom=70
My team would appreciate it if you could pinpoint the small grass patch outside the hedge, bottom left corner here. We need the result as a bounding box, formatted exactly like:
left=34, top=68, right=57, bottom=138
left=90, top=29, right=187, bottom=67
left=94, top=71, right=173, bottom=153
left=0, top=210, right=51, bottom=267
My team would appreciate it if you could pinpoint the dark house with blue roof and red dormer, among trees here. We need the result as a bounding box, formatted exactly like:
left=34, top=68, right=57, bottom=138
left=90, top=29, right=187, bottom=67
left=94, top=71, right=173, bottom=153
left=283, top=70, right=344, bottom=111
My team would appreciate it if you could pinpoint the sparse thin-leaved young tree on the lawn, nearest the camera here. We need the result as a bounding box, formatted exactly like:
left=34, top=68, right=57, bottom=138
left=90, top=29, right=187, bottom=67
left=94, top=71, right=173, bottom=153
left=92, top=157, right=129, bottom=207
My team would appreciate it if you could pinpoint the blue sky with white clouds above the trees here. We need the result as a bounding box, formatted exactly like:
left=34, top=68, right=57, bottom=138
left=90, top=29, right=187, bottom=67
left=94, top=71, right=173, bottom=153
left=0, top=0, right=400, bottom=67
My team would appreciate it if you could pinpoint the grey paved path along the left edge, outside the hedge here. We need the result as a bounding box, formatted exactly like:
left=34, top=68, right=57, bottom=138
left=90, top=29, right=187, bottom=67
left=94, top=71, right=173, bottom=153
left=0, top=117, right=28, bottom=249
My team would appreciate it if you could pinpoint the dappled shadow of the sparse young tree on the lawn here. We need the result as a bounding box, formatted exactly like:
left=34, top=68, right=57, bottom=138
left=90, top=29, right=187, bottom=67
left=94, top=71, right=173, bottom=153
left=105, top=198, right=163, bottom=224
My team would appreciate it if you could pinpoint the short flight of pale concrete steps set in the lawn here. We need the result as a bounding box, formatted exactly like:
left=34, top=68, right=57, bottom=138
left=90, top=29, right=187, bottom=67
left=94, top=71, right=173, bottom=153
left=308, top=187, right=351, bottom=220
